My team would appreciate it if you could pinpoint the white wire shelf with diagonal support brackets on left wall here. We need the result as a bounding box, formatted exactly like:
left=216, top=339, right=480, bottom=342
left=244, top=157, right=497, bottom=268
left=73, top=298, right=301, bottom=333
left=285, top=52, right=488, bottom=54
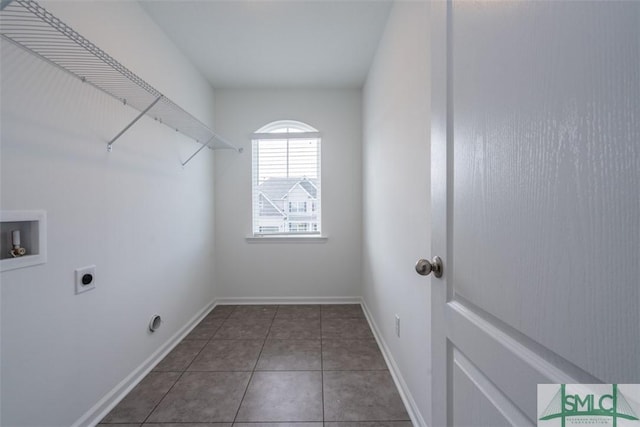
left=0, top=0, right=242, bottom=166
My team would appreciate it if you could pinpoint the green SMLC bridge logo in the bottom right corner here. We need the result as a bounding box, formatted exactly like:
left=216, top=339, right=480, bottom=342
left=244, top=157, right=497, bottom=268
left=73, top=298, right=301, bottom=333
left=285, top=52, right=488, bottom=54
left=539, top=384, right=638, bottom=427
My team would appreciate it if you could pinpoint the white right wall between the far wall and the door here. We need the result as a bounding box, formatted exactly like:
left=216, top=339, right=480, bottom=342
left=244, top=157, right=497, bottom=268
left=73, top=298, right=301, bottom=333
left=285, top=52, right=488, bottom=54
left=363, top=2, right=430, bottom=419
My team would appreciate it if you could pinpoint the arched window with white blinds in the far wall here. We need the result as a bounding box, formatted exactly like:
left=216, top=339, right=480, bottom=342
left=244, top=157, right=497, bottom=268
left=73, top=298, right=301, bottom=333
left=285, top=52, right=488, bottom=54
left=252, top=120, right=321, bottom=235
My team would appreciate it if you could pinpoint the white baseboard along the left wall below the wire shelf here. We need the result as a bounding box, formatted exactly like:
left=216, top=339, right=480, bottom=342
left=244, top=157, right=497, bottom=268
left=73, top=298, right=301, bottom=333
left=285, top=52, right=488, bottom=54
left=72, top=299, right=217, bottom=427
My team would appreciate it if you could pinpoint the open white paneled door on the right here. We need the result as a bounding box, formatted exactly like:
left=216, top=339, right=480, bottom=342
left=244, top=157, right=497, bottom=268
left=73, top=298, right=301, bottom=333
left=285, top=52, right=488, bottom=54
left=427, top=1, right=640, bottom=427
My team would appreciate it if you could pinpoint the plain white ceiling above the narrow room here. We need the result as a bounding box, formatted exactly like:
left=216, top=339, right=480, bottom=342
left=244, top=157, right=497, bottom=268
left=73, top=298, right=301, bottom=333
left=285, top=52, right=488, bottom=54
left=140, top=0, right=391, bottom=88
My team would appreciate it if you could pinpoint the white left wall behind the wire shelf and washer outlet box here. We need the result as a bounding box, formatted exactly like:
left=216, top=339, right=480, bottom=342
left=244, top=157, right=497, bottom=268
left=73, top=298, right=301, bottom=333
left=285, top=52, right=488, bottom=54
left=0, top=2, right=214, bottom=427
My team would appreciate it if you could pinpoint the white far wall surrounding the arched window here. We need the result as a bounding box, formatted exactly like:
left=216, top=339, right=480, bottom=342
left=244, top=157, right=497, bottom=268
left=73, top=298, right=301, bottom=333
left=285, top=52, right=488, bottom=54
left=215, top=90, right=362, bottom=299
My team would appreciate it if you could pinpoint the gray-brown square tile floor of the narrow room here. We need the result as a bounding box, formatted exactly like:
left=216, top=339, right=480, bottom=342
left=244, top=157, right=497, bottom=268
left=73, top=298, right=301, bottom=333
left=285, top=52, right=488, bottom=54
left=99, top=305, right=411, bottom=427
